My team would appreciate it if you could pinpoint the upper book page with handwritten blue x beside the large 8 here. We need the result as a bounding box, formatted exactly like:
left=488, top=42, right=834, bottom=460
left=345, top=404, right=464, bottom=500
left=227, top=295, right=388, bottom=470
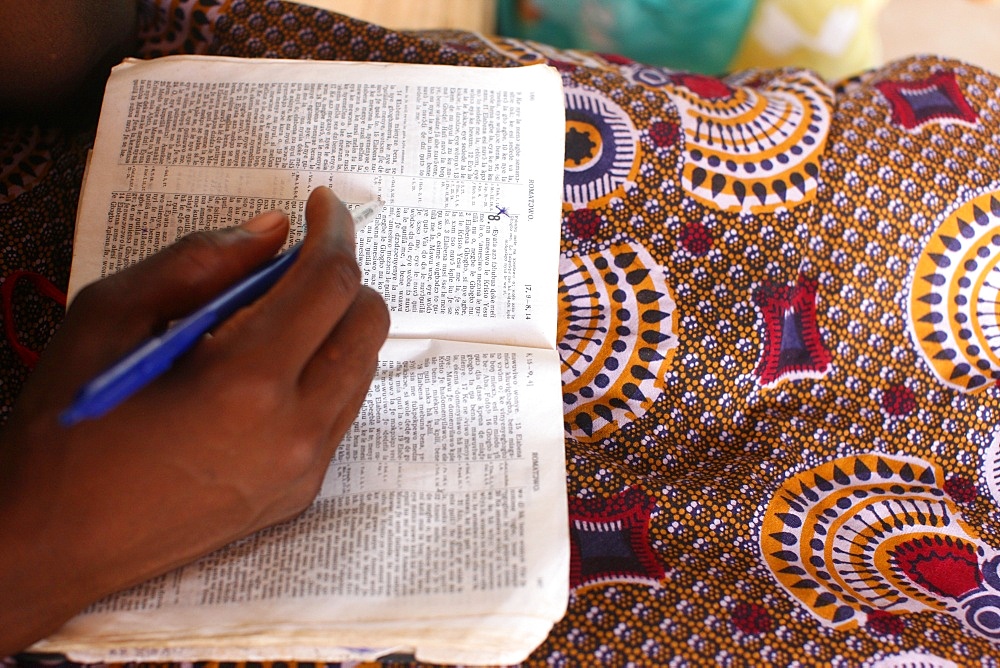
left=70, top=56, right=564, bottom=348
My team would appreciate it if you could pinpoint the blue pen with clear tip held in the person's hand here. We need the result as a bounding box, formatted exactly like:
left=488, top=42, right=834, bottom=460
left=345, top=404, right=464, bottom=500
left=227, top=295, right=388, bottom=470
left=59, top=200, right=383, bottom=427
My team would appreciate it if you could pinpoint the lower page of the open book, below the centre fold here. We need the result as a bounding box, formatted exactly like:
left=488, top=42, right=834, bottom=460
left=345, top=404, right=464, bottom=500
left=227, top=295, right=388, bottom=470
left=42, top=339, right=569, bottom=649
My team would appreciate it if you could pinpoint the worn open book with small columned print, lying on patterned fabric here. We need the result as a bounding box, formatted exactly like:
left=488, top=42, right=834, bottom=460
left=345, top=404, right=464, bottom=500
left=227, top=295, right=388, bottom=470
left=33, top=56, right=569, bottom=664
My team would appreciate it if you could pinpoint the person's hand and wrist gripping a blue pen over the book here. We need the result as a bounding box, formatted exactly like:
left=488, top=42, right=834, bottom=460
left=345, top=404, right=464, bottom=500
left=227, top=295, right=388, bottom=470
left=0, top=188, right=389, bottom=656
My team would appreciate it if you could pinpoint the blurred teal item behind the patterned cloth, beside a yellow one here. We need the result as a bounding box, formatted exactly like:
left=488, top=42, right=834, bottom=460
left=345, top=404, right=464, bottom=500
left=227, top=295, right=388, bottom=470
left=497, top=0, right=755, bottom=74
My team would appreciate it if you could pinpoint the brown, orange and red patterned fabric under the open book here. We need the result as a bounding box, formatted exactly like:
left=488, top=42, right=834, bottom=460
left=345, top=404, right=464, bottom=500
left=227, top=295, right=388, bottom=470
left=0, top=0, right=1000, bottom=666
